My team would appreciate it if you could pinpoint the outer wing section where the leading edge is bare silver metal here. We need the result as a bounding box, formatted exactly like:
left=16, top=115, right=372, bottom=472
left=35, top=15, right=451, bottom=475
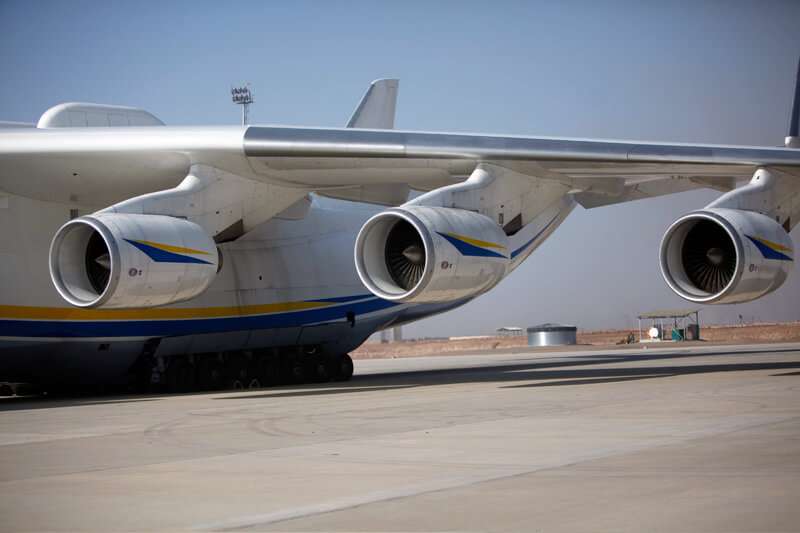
left=244, top=127, right=800, bottom=201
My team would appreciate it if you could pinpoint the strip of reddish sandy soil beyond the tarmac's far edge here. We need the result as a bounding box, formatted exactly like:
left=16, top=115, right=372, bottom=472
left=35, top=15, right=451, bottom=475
left=351, top=322, right=800, bottom=359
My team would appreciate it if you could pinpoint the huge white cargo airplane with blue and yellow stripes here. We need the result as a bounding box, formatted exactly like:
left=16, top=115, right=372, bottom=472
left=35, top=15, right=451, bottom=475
left=0, top=66, right=800, bottom=391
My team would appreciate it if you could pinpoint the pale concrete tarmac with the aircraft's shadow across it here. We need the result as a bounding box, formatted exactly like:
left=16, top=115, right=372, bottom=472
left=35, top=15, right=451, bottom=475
left=0, top=344, right=800, bottom=532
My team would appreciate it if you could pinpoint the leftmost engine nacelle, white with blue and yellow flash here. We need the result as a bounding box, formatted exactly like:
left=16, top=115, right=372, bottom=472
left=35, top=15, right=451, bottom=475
left=50, top=213, right=219, bottom=308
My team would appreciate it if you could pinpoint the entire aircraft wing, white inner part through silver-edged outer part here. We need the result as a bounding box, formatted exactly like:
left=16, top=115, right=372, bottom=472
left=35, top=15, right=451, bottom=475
left=0, top=126, right=800, bottom=206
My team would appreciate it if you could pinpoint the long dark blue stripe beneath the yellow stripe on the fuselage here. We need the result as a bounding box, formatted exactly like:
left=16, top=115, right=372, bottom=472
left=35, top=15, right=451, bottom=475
left=0, top=297, right=399, bottom=338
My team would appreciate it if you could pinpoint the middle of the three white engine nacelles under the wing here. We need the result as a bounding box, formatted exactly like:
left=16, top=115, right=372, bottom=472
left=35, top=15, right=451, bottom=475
left=355, top=206, right=509, bottom=302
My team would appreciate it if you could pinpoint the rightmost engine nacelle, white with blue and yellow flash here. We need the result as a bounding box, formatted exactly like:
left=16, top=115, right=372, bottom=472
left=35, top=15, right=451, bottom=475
left=661, top=208, right=793, bottom=304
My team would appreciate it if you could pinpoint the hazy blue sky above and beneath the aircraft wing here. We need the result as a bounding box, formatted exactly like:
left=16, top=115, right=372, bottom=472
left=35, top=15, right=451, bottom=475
left=0, top=0, right=800, bottom=335
